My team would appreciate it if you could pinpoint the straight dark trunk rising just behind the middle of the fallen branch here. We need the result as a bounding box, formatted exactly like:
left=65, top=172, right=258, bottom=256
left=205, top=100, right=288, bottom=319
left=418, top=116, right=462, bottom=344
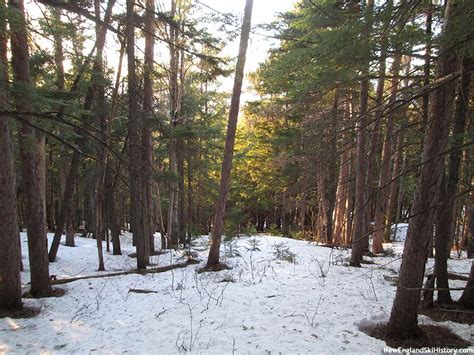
left=126, top=0, right=148, bottom=269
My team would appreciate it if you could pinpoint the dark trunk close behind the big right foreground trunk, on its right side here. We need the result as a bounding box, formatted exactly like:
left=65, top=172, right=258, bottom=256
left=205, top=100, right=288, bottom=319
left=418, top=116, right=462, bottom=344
left=434, top=58, right=472, bottom=303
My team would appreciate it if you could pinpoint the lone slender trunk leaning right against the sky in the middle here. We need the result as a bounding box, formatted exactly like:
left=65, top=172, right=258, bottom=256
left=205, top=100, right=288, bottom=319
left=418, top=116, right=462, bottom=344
left=207, top=0, right=253, bottom=267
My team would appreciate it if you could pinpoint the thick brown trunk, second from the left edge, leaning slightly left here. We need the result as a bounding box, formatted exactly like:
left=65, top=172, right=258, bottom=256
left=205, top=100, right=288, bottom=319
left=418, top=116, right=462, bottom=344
left=9, top=0, right=52, bottom=297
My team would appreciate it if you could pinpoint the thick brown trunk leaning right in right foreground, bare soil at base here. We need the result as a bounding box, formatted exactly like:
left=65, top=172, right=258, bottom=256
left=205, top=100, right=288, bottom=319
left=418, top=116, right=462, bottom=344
left=388, top=0, right=455, bottom=339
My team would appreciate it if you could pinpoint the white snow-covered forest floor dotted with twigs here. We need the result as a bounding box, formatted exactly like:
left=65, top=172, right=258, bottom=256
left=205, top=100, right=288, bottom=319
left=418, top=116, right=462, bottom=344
left=0, top=229, right=474, bottom=354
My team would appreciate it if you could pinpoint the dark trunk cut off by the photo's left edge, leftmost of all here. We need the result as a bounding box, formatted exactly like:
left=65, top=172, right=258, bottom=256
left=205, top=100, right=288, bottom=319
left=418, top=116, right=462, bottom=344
left=0, top=0, right=22, bottom=309
